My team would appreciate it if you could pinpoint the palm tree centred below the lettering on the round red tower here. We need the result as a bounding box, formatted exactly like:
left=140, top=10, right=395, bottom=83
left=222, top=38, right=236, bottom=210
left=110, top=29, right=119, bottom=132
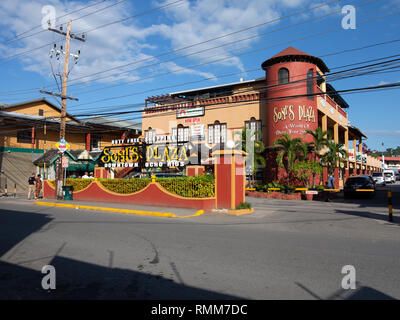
left=274, top=133, right=304, bottom=187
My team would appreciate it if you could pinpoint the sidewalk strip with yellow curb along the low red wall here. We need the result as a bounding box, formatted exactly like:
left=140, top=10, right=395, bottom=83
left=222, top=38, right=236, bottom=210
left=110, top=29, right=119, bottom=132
left=32, top=199, right=204, bottom=218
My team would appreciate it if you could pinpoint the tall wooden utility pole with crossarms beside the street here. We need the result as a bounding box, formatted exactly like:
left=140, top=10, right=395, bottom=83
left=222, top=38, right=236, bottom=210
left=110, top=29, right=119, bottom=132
left=40, top=19, right=85, bottom=200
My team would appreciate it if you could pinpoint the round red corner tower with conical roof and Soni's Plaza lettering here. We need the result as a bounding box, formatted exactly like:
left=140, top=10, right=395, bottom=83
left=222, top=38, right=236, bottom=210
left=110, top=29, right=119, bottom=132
left=261, top=47, right=329, bottom=146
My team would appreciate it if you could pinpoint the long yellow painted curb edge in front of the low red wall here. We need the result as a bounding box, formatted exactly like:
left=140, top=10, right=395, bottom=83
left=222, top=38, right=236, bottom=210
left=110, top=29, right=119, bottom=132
left=34, top=201, right=204, bottom=218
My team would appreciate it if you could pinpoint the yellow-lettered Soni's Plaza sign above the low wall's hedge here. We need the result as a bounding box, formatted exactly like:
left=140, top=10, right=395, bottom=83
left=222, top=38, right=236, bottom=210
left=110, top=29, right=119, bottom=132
left=100, top=139, right=189, bottom=168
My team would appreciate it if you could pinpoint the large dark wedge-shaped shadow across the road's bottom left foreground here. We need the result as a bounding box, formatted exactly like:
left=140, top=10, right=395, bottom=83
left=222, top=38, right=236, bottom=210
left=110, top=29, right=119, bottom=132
left=0, top=256, right=243, bottom=300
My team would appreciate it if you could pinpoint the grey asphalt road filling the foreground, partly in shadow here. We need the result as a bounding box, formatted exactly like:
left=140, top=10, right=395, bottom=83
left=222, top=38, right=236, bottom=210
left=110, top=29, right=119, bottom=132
left=0, top=184, right=400, bottom=299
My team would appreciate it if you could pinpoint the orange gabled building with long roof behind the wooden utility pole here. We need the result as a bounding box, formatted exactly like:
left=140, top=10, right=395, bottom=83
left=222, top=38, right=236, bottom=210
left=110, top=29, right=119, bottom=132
left=0, top=98, right=141, bottom=192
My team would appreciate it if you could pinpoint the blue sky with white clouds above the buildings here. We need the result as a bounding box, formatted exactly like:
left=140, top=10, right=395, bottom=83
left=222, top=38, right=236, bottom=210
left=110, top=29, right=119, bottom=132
left=0, top=0, right=400, bottom=150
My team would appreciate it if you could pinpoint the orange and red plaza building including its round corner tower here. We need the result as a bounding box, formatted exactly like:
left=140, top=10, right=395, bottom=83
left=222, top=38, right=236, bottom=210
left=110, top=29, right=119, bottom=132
left=142, top=47, right=382, bottom=186
